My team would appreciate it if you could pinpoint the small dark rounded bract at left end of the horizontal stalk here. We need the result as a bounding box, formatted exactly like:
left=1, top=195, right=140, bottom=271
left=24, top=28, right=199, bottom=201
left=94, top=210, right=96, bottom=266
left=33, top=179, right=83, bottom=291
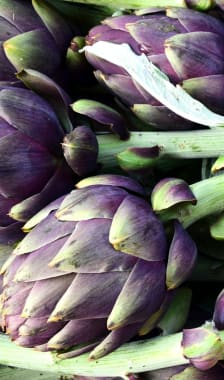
left=62, top=126, right=98, bottom=177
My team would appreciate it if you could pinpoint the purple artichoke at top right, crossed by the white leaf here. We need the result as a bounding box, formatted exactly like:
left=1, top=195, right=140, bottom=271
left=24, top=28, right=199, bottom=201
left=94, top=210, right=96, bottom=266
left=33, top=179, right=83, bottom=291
left=86, top=8, right=224, bottom=130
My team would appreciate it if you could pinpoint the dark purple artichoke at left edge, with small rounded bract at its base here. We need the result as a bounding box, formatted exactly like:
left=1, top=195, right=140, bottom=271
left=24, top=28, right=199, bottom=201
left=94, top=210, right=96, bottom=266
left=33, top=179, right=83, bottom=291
left=0, top=77, right=97, bottom=250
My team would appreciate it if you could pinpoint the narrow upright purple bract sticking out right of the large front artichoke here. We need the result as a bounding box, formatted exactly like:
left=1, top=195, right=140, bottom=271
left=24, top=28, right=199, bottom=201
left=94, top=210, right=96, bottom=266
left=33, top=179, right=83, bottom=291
left=166, top=220, right=197, bottom=289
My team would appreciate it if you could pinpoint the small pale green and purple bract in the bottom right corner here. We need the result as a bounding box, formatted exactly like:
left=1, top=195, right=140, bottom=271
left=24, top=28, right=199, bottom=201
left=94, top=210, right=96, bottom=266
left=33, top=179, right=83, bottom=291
left=182, top=322, right=224, bottom=371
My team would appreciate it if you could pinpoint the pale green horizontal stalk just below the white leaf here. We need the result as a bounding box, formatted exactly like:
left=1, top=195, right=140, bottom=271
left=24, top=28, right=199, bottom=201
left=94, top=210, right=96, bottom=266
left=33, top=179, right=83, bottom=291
left=97, top=128, right=224, bottom=169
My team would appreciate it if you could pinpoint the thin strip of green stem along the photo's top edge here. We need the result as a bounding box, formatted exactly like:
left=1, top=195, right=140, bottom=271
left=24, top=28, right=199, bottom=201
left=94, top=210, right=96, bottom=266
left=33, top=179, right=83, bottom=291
left=60, top=0, right=186, bottom=9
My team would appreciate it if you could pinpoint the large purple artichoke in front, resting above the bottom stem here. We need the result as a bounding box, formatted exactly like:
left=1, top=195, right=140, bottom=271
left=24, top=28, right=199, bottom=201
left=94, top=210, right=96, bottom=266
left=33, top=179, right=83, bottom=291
left=1, top=174, right=195, bottom=358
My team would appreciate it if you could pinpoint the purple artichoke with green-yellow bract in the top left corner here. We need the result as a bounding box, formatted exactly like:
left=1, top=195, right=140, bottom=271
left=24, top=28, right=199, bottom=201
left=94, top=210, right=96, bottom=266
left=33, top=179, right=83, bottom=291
left=0, top=0, right=73, bottom=85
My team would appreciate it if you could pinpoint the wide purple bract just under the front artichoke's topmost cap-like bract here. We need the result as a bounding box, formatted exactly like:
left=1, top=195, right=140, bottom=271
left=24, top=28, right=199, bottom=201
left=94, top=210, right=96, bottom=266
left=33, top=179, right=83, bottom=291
left=56, top=185, right=127, bottom=221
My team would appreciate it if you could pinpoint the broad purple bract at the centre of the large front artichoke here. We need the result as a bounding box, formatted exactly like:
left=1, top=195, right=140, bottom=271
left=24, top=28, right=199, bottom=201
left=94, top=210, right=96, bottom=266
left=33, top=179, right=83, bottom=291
left=50, top=219, right=136, bottom=273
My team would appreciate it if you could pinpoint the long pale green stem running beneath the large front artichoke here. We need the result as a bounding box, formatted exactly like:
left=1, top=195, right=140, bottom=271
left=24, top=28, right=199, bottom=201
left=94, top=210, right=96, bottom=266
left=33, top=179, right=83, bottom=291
left=0, top=333, right=188, bottom=379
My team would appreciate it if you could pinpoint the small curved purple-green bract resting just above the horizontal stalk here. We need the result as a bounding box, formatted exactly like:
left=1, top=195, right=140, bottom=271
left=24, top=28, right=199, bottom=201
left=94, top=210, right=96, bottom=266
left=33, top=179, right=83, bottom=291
left=72, top=99, right=129, bottom=140
